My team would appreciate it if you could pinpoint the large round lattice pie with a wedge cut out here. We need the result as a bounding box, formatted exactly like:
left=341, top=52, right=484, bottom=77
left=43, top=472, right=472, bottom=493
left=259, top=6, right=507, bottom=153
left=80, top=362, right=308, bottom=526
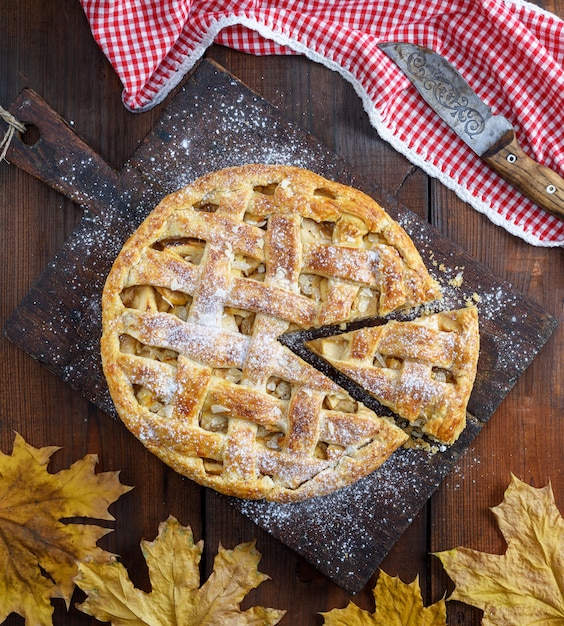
left=101, top=165, right=446, bottom=501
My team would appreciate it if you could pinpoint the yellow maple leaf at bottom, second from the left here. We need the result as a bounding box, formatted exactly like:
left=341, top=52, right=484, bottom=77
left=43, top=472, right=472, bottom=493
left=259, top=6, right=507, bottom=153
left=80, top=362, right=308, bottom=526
left=75, top=516, right=285, bottom=626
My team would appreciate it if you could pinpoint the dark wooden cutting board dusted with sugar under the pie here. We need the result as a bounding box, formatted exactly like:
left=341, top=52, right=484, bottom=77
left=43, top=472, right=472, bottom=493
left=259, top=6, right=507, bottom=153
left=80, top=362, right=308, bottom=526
left=5, top=61, right=556, bottom=592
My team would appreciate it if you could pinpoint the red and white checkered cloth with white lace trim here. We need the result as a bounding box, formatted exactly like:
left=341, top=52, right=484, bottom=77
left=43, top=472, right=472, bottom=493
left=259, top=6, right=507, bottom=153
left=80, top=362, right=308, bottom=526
left=81, top=0, right=564, bottom=246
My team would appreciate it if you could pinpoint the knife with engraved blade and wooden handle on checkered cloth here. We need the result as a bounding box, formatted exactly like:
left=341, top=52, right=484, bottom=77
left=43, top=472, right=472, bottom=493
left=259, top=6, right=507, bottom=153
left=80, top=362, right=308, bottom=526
left=378, top=43, right=564, bottom=218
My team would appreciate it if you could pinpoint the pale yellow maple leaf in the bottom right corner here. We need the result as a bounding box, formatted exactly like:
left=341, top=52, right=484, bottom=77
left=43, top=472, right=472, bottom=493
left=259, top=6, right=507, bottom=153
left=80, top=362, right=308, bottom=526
left=437, top=475, right=564, bottom=626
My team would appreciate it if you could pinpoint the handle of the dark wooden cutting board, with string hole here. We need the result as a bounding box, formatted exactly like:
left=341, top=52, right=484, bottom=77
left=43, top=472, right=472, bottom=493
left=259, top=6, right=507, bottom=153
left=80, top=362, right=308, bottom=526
left=6, top=89, right=119, bottom=216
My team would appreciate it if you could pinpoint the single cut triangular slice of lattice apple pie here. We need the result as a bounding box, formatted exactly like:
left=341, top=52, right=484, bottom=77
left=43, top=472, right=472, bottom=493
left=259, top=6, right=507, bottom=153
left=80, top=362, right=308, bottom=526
left=305, top=307, right=480, bottom=444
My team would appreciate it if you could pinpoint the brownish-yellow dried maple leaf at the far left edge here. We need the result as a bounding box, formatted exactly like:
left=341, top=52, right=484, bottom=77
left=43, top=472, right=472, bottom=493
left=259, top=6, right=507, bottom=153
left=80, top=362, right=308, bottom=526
left=0, top=435, right=130, bottom=626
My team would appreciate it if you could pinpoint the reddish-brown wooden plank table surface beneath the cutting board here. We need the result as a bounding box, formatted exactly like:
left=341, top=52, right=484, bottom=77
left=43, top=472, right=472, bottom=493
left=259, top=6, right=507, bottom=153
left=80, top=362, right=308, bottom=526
left=0, top=0, right=564, bottom=626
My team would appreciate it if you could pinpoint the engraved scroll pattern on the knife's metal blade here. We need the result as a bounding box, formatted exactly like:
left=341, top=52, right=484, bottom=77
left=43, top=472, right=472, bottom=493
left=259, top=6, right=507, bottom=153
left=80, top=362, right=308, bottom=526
left=407, top=52, right=486, bottom=138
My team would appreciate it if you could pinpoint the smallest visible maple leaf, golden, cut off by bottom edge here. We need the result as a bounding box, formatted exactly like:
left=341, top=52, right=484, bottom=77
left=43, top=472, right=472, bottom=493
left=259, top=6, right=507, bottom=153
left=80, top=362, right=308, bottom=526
left=321, top=571, right=446, bottom=626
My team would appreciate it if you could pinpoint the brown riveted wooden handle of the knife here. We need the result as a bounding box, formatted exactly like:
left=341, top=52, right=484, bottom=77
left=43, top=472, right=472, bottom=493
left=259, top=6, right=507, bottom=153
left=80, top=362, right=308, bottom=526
left=482, top=132, right=564, bottom=219
